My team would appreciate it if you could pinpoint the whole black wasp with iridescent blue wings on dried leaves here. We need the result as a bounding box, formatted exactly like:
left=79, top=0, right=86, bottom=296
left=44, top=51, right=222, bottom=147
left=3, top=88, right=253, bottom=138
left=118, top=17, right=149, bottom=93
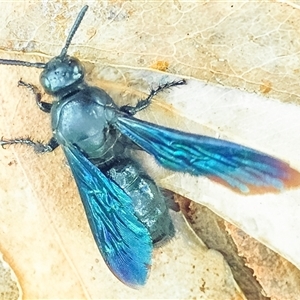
left=0, top=6, right=300, bottom=288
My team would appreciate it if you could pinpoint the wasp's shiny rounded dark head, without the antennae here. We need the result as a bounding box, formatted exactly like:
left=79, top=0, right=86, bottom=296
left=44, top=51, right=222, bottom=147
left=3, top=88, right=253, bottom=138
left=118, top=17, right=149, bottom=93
left=40, top=56, right=84, bottom=95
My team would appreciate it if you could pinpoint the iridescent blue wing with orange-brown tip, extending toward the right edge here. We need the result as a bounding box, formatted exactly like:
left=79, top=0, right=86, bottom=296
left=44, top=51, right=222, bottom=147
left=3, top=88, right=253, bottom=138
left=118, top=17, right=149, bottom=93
left=115, top=115, right=300, bottom=194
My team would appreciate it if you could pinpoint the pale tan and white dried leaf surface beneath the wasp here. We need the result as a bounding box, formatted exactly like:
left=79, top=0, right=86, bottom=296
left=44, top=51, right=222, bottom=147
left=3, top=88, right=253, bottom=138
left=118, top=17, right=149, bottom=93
left=0, top=1, right=300, bottom=299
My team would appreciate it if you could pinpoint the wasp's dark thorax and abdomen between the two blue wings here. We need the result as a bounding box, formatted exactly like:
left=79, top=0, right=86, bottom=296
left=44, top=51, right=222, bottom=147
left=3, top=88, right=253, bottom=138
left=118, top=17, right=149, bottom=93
left=49, top=71, right=175, bottom=244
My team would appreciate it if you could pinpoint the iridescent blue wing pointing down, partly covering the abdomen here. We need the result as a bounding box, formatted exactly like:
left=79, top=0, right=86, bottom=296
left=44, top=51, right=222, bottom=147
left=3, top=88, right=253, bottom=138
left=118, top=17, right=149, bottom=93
left=63, top=147, right=152, bottom=287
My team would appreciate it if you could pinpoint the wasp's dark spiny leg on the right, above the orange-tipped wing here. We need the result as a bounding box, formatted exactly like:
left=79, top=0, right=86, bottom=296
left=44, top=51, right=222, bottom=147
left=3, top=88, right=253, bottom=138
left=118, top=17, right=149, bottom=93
left=120, top=79, right=186, bottom=116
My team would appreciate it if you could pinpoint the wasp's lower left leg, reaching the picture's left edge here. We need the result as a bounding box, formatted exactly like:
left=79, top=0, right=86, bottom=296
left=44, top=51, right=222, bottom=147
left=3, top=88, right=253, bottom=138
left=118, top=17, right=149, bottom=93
left=0, top=137, right=59, bottom=153
